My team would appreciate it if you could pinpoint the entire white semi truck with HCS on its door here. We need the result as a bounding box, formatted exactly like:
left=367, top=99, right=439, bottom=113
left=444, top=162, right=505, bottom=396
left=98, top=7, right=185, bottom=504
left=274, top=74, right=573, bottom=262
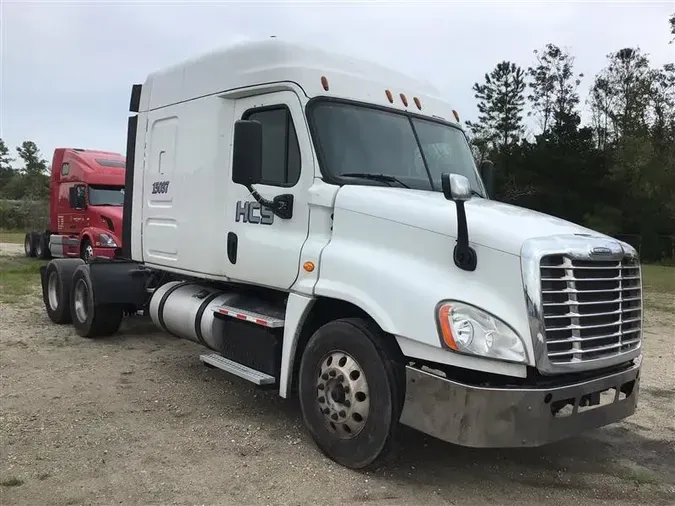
left=41, top=39, right=642, bottom=468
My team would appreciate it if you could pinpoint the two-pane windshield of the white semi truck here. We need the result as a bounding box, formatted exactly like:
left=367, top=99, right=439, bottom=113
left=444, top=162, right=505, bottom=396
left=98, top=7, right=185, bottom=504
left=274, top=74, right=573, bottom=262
left=310, top=101, right=485, bottom=195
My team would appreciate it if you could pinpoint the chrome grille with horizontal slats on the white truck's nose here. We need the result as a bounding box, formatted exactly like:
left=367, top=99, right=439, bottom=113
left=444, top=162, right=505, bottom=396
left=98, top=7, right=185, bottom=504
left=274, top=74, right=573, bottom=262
left=540, top=255, right=642, bottom=364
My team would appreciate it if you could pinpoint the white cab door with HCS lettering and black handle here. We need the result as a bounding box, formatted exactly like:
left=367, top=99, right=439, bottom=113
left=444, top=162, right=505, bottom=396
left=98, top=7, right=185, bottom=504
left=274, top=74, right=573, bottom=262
left=224, top=91, right=314, bottom=289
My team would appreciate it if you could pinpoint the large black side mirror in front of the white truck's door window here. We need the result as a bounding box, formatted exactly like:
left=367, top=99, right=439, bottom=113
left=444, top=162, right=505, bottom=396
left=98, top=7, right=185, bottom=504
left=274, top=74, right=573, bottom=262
left=232, top=120, right=262, bottom=187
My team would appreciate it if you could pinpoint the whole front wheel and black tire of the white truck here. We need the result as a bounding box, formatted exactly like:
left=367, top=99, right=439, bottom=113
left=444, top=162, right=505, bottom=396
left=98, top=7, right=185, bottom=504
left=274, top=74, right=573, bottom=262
left=299, top=318, right=405, bottom=469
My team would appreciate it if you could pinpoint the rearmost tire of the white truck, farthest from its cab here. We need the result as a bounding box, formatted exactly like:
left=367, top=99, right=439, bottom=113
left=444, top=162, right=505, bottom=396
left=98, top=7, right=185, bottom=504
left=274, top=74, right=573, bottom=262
left=42, top=258, right=84, bottom=324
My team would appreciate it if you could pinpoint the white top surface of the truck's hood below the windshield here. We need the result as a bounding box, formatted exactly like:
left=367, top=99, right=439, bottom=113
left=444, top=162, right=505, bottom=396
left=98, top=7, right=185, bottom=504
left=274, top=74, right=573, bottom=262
left=335, top=185, right=607, bottom=255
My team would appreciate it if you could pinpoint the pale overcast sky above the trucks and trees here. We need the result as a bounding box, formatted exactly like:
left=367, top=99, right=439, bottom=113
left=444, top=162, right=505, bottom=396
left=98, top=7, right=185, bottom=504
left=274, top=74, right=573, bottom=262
left=0, top=0, right=675, bottom=168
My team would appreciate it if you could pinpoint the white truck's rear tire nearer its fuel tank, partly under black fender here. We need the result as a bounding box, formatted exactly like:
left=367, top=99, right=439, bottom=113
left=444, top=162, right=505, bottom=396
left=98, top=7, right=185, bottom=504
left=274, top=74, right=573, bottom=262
left=70, top=264, right=124, bottom=338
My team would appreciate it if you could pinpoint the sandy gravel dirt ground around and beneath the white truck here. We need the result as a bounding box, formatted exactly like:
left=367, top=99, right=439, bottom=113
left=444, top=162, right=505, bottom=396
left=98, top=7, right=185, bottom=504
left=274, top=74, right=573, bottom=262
left=0, top=250, right=675, bottom=506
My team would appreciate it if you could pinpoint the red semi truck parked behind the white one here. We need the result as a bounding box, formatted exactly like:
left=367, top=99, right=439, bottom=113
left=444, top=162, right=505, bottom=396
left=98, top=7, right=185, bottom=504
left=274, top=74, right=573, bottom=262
left=24, top=148, right=126, bottom=262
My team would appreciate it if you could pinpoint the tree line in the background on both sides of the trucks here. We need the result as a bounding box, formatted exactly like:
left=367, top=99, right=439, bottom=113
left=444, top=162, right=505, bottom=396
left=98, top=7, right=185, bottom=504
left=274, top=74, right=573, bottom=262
left=0, top=13, right=675, bottom=261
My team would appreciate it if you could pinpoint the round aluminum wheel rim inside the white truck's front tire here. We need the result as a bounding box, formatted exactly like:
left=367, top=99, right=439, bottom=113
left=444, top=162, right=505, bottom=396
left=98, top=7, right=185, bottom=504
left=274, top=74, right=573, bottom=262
left=316, top=351, right=370, bottom=439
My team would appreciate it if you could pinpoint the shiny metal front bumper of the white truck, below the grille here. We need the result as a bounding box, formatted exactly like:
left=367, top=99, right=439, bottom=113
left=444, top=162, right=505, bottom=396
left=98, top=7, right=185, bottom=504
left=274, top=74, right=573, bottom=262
left=400, top=359, right=641, bottom=448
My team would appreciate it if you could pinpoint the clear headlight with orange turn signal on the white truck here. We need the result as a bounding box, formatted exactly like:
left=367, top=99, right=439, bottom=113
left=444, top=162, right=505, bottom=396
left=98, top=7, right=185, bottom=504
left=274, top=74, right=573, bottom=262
left=437, top=301, right=527, bottom=363
